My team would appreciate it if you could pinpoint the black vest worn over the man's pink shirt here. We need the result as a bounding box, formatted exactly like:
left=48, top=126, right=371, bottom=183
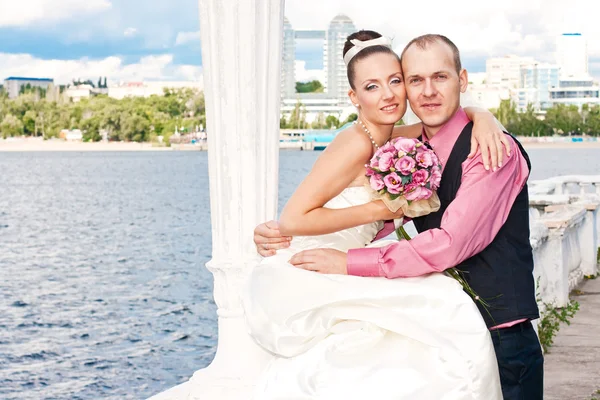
left=413, top=122, right=539, bottom=327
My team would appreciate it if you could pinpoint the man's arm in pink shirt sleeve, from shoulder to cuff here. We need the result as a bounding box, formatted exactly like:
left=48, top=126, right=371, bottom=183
left=347, top=139, right=529, bottom=278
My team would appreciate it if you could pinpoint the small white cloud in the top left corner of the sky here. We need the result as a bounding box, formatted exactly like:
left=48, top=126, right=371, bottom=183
left=0, top=0, right=112, bottom=27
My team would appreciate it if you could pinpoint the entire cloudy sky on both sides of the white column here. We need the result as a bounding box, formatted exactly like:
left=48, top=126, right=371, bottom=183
left=0, top=0, right=600, bottom=84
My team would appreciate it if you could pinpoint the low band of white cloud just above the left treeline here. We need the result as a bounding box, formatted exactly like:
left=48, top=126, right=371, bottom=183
left=0, top=53, right=202, bottom=84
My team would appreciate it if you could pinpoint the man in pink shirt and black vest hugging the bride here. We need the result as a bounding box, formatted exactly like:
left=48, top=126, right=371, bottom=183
left=255, top=35, right=543, bottom=400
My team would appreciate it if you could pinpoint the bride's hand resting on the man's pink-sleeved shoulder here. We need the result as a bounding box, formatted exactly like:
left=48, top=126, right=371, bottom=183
left=468, top=108, right=510, bottom=171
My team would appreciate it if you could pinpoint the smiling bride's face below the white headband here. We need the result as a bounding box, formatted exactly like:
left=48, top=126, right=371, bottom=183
left=350, top=53, right=406, bottom=125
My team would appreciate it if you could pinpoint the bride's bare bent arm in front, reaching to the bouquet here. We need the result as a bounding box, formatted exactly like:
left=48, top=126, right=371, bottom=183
left=279, top=129, right=394, bottom=236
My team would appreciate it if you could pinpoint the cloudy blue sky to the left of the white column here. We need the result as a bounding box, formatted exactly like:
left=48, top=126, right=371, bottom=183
left=0, top=0, right=202, bottom=80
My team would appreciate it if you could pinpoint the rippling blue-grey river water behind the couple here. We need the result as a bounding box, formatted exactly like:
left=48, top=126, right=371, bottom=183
left=0, top=149, right=600, bottom=399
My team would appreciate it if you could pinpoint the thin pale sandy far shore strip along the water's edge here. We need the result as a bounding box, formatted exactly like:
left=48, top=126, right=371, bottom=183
left=0, top=138, right=600, bottom=152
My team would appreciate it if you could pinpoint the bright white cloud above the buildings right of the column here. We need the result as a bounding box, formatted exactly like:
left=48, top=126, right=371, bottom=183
left=285, top=0, right=600, bottom=61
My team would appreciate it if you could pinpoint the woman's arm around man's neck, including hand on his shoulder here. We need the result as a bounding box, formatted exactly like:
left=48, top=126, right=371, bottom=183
left=392, top=106, right=510, bottom=169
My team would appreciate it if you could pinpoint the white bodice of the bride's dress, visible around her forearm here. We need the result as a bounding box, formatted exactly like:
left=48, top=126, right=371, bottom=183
left=290, top=186, right=383, bottom=253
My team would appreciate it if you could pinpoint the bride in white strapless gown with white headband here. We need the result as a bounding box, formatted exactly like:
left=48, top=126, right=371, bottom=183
left=241, top=31, right=504, bottom=400
